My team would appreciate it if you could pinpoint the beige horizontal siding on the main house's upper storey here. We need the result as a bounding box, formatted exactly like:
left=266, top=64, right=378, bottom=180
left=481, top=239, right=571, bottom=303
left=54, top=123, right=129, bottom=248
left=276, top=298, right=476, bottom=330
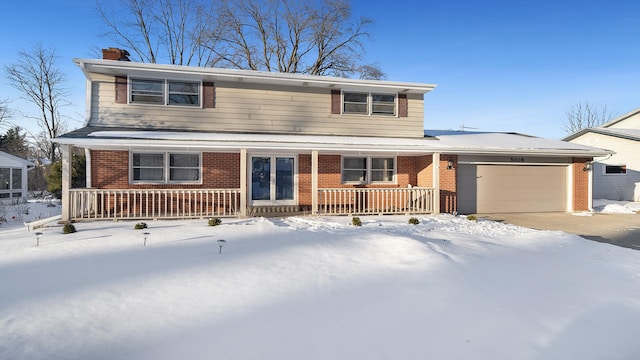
left=89, top=74, right=424, bottom=137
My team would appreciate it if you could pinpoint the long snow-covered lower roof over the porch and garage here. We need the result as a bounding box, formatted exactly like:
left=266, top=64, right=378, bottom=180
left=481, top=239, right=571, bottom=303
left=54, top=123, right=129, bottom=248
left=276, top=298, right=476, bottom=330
left=55, top=127, right=612, bottom=157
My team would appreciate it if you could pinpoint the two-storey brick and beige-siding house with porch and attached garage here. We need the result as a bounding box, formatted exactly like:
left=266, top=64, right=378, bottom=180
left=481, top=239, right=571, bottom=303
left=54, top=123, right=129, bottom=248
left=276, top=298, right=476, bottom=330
left=56, top=48, right=609, bottom=219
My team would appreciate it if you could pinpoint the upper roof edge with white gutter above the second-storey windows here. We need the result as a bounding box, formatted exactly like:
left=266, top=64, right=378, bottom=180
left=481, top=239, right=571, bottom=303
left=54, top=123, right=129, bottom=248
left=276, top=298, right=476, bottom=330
left=73, top=59, right=436, bottom=94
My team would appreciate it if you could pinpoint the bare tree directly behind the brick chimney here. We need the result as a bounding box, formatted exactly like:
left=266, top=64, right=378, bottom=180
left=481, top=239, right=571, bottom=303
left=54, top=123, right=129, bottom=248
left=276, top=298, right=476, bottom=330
left=97, top=0, right=215, bottom=66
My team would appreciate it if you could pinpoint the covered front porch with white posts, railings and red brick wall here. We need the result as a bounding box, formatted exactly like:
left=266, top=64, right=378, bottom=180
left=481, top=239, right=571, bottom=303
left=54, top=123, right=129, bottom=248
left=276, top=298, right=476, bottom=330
left=56, top=132, right=446, bottom=221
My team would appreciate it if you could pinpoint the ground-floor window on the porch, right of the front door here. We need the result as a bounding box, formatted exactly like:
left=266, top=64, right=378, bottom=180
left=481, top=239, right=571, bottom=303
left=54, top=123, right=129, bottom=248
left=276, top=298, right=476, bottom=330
left=342, top=156, right=396, bottom=184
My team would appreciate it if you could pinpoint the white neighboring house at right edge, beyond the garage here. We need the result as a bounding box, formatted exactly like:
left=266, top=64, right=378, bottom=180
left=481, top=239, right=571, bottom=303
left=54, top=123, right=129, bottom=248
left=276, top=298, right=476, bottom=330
left=563, top=108, right=640, bottom=201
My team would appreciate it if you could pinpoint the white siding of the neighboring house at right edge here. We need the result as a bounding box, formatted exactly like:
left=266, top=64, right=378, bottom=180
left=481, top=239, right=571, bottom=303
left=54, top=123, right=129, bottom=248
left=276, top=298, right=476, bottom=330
left=571, top=133, right=640, bottom=201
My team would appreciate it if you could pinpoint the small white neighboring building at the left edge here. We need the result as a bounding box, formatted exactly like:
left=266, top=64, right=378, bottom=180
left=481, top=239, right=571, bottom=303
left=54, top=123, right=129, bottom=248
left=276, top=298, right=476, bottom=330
left=0, top=151, right=34, bottom=202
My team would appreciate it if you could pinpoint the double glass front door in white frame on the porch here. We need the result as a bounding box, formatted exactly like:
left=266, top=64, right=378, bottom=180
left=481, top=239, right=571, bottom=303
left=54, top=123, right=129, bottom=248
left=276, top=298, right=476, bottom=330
left=250, top=155, right=296, bottom=205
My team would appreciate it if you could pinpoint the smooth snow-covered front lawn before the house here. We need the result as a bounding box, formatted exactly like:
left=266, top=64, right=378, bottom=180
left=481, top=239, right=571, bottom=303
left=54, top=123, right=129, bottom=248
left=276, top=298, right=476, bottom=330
left=0, top=202, right=640, bottom=360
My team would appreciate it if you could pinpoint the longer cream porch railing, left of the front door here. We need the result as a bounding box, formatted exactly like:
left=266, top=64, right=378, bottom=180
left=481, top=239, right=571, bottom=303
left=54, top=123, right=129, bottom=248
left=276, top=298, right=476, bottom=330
left=69, top=189, right=240, bottom=220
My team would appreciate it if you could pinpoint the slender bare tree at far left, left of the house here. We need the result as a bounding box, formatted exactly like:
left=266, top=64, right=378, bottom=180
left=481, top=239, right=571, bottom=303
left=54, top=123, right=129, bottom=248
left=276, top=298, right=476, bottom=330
left=5, top=46, right=68, bottom=162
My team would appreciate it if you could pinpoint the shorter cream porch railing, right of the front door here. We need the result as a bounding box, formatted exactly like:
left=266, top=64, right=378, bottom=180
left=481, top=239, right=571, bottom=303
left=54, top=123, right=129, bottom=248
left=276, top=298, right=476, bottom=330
left=318, top=187, right=434, bottom=215
